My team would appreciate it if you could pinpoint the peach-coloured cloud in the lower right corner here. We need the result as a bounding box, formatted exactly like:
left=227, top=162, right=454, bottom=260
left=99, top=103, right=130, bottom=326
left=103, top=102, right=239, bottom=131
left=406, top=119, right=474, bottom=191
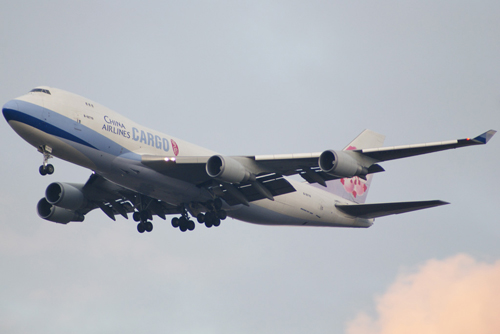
left=346, top=254, right=500, bottom=334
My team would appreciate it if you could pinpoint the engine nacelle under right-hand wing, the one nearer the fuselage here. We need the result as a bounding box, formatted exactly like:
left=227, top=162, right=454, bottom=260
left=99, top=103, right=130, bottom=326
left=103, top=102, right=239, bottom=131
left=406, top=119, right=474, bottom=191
left=206, top=155, right=252, bottom=183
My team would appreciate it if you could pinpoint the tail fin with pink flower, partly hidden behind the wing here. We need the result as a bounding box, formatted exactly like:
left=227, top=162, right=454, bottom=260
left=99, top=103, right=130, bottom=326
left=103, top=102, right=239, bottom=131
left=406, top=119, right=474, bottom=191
left=313, top=130, right=385, bottom=203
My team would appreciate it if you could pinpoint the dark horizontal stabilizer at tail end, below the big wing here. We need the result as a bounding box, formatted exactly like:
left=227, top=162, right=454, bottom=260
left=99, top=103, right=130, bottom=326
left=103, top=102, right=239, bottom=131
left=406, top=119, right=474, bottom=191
left=335, top=200, right=450, bottom=218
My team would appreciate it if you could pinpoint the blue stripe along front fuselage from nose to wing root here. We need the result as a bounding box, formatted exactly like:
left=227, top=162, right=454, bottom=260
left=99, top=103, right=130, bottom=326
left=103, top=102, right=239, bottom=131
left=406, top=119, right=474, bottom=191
left=3, top=100, right=141, bottom=161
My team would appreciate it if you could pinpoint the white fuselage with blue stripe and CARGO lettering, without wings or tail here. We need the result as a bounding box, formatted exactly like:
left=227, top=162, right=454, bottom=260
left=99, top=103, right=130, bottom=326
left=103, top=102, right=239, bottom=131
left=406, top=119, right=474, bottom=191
left=2, top=88, right=373, bottom=227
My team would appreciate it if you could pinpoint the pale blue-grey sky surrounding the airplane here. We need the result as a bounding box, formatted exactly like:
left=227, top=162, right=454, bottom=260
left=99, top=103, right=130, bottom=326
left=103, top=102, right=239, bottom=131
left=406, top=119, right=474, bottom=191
left=0, top=0, right=500, bottom=334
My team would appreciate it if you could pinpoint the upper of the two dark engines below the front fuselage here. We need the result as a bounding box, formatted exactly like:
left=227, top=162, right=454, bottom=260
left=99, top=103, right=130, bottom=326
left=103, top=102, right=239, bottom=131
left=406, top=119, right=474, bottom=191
left=45, top=182, right=86, bottom=211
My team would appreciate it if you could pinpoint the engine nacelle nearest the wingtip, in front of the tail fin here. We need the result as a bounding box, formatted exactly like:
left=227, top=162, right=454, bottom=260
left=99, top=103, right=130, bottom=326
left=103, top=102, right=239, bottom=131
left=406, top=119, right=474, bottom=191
left=318, top=150, right=368, bottom=177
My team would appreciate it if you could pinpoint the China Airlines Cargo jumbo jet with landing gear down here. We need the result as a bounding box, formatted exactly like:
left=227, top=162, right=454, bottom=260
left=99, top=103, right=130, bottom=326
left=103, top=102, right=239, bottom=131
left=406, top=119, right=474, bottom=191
left=2, top=86, right=496, bottom=233
